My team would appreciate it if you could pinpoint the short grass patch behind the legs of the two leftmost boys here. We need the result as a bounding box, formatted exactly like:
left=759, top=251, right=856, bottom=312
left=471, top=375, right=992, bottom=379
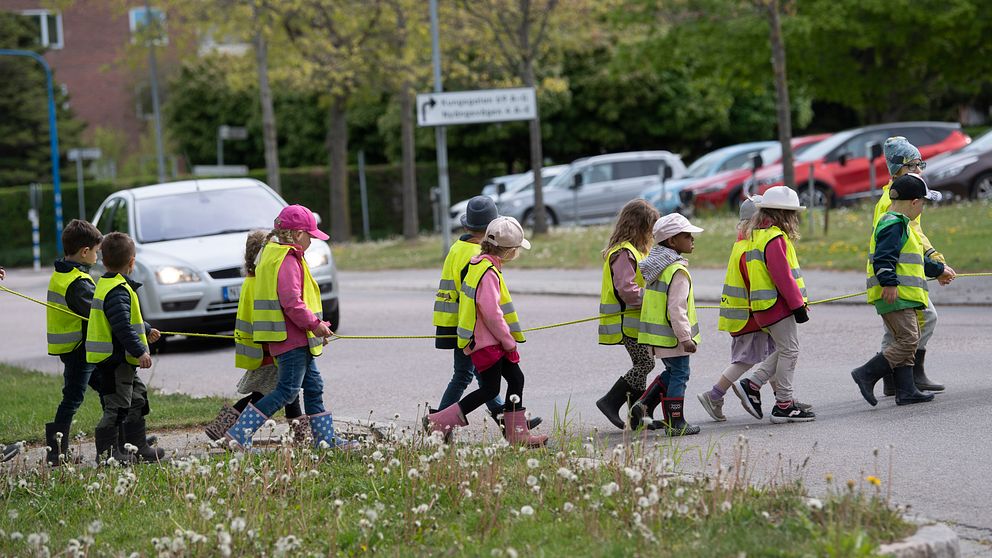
left=0, top=364, right=227, bottom=443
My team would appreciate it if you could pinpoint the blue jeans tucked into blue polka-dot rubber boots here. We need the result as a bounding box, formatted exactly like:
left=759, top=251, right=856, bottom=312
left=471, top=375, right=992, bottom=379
left=255, top=347, right=324, bottom=417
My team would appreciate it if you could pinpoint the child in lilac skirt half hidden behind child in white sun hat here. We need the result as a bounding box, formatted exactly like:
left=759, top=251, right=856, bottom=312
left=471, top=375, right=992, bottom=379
left=696, top=196, right=812, bottom=422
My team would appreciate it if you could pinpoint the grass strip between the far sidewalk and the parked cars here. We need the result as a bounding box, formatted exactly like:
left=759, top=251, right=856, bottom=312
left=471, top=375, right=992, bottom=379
left=334, top=202, right=992, bottom=273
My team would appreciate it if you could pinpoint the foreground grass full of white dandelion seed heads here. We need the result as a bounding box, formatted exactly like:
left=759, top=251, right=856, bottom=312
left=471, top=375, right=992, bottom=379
left=0, top=431, right=913, bottom=558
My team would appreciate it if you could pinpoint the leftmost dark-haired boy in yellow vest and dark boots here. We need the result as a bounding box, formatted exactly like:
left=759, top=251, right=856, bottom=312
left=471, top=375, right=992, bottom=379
left=45, top=219, right=103, bottom=466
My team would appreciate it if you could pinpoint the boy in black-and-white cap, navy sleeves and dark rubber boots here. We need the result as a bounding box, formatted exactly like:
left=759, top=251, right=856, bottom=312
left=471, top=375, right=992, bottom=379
left=851, top=173, right=945, bottom=406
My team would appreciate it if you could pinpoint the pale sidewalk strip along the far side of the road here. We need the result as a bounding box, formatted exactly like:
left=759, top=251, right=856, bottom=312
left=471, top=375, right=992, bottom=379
left=338, top=265, right=992, bottom=306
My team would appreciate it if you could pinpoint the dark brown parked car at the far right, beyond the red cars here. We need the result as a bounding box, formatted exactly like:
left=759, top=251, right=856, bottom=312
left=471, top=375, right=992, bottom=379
left=923, top=131, right=992, bottom=200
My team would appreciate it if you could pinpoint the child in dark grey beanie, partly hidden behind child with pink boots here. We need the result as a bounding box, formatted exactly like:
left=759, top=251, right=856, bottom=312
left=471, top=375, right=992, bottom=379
left=424, top=196, right=541, bottom=434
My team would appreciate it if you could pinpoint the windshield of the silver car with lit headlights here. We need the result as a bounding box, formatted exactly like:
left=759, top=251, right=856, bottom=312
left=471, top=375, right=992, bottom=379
left=135, top=188, right=282, bottom=243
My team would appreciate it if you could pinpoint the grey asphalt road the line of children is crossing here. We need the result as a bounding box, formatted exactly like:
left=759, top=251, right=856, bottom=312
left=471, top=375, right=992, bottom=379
left=0, top=270, right=992, bottom=552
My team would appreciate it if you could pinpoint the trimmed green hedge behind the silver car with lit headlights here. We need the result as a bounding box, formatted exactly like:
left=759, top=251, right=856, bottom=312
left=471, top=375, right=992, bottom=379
left=0, top=163, right=503, bottom=267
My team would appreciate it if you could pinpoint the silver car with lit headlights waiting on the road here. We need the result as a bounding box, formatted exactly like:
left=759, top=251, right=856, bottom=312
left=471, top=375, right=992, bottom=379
left=93, top=178, right=341, bottom=333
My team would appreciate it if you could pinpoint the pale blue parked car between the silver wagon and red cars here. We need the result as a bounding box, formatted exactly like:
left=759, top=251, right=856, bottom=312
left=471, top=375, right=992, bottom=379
left=641, top=141, right=775, bottom=215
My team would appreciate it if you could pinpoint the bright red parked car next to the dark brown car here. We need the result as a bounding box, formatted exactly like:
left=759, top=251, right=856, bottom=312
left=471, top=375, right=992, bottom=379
left=752, top=122, right=971, bottom=207
